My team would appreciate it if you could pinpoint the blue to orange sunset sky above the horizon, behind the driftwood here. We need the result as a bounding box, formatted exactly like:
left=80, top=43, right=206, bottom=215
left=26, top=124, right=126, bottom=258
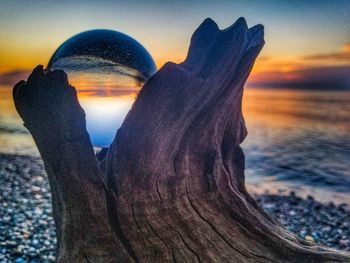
left=0, top=0, right=350, bottom=89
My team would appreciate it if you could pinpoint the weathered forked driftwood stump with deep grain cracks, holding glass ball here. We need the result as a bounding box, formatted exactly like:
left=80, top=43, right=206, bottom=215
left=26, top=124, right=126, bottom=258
left=14, top=18, right=350, bottom=263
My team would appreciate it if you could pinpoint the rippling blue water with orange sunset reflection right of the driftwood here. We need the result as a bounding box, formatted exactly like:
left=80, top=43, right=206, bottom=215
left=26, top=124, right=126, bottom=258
left=242, top=89, right=350, bottom=198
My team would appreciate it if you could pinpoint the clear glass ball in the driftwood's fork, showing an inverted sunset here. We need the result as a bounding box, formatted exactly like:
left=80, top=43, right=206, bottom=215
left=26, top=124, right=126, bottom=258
left=48, top=29, right=156, bottom=147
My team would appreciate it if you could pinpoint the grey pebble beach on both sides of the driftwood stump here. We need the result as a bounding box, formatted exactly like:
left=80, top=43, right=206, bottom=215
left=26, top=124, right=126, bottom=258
left=0, top=154, right=350, bottom=263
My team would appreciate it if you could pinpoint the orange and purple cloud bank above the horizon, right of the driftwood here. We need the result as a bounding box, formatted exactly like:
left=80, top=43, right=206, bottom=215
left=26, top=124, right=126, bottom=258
left=248, top=42, right=350, bottom=90
